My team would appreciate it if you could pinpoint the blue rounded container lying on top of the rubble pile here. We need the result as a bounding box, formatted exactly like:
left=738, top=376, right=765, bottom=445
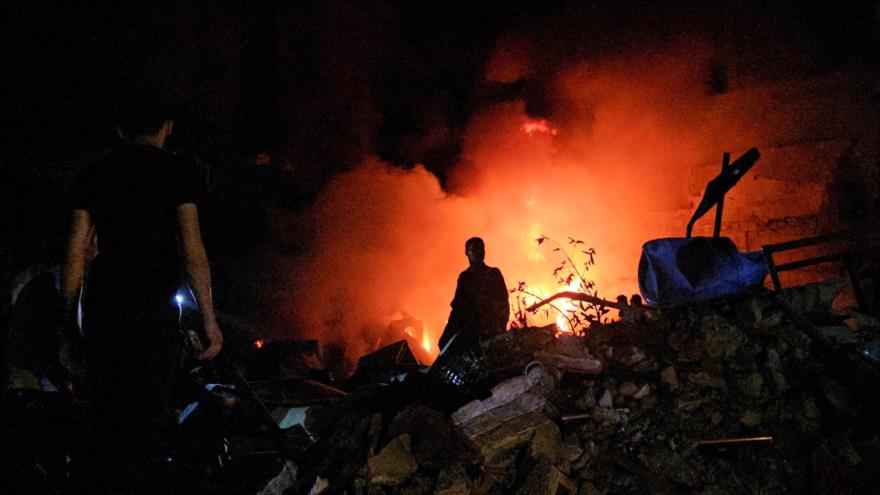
left=639, top=237, right=767, bottom=307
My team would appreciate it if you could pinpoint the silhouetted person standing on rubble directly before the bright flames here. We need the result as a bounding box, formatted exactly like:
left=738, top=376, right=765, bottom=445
left=439, top=237, right=510, bottom=352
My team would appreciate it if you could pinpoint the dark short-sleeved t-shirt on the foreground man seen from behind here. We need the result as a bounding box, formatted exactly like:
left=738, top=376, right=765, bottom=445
left=73, top=145, right=200, bottom=309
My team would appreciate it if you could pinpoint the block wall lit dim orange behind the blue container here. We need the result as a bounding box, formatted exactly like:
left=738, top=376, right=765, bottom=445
left=664, top=74, right=880, bottom=285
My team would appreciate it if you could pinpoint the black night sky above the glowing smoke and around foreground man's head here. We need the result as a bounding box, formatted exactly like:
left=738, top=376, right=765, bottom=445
left=0, top=0, right=880, bottom=330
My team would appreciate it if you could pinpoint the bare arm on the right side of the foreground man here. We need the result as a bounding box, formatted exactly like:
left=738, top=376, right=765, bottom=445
left=177, top=203, right=223, bottom=359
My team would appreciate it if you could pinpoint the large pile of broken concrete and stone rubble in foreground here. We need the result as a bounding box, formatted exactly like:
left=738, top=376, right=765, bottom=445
left=266, top=285, right=880, bottom=495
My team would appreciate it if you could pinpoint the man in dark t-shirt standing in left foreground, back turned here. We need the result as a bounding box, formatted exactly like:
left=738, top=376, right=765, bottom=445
left=61, top=99, right=223, bottom=493
